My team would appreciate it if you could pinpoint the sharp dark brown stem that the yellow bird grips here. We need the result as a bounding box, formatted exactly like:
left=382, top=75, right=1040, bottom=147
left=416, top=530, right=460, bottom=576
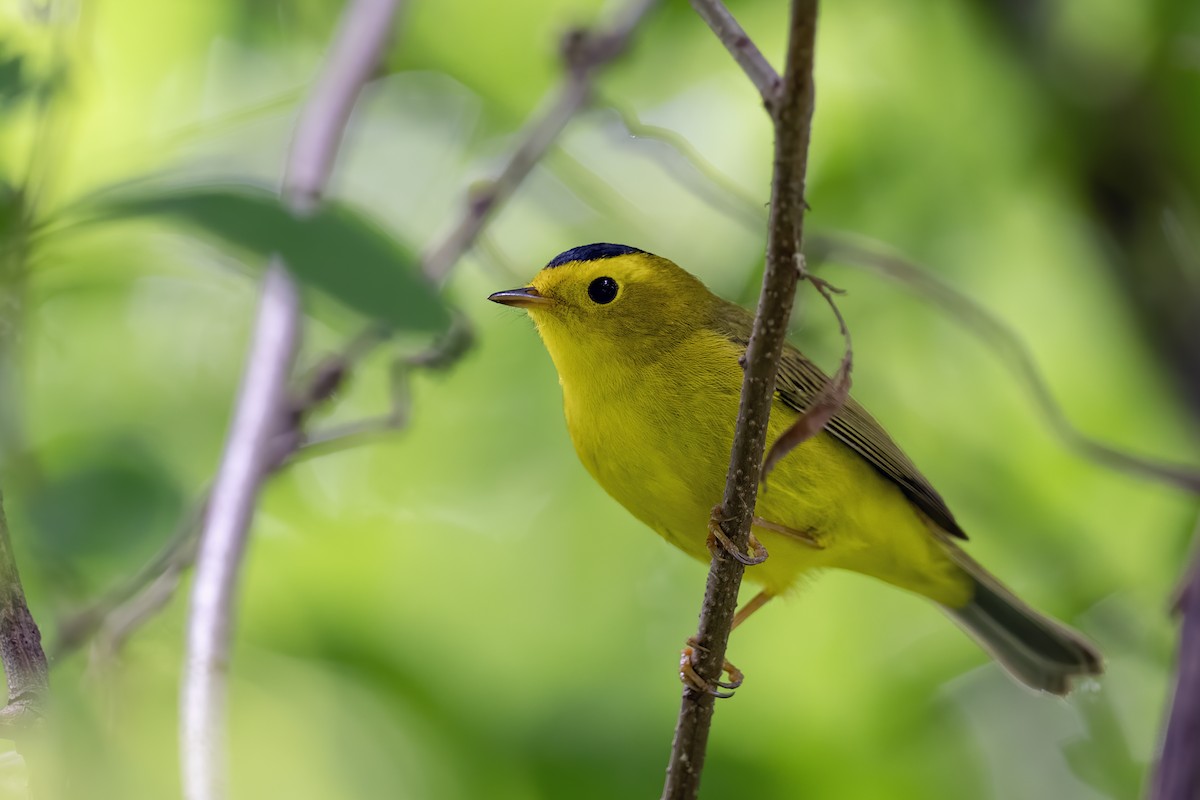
left=662, top=0, right=817, bottom=800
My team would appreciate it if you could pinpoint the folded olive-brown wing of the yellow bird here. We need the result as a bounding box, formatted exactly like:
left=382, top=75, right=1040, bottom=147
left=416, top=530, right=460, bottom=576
left=716, top=303, right=967, bottom=539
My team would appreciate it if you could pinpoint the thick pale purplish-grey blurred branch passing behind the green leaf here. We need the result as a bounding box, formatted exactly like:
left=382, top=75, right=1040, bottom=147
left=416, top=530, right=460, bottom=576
left=180, top=0, right=398, bottom=800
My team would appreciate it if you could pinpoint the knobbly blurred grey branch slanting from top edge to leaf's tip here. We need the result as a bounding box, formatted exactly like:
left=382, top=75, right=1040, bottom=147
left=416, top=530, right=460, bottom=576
left=425, top=0, right=658, bottom=283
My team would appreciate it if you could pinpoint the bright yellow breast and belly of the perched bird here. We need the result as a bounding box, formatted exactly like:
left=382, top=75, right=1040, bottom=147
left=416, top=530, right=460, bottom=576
left=556, top=327, right=968, bottom=604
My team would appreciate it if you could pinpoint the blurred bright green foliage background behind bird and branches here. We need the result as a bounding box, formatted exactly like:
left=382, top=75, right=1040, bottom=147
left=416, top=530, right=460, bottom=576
left=0, top=0, right=1200, bottom=800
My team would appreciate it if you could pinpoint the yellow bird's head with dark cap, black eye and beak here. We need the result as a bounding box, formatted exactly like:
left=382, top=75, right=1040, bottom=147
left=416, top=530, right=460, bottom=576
left=488, top=243, right=714, bottom=372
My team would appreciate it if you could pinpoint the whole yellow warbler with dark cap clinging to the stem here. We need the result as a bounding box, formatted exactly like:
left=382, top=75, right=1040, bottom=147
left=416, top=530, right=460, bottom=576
left=490, top=243, right=1102, bottom=694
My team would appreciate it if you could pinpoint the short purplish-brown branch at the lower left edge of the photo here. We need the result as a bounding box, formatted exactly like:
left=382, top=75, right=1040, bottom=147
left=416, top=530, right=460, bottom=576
left=0, top=484, right=49, bottom=739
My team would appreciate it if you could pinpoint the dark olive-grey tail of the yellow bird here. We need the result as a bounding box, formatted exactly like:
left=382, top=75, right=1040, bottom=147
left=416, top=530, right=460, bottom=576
left=943, top=543, right=1104, bottom=694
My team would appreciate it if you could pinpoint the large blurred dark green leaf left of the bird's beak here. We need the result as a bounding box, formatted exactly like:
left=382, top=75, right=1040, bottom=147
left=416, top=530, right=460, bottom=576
left=92, top=185, right=450, bottom=332
